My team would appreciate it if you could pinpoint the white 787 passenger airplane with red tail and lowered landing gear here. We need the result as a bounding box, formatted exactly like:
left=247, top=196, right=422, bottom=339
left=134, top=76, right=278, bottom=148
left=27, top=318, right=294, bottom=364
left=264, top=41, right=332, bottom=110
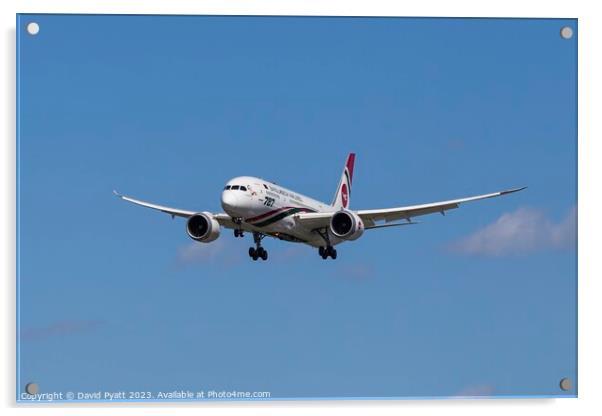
left=113, top=153, right=526, bottom=260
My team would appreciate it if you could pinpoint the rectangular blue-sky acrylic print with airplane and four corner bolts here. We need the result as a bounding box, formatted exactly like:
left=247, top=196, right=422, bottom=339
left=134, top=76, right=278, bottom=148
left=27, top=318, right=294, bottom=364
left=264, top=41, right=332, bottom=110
left=17, top=14, right=577, bottom=402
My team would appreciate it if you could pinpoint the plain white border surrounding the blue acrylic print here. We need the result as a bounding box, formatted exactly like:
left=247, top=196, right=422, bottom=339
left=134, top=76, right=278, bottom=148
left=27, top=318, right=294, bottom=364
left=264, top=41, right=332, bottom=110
left=0, top=0, right=602, bottom=415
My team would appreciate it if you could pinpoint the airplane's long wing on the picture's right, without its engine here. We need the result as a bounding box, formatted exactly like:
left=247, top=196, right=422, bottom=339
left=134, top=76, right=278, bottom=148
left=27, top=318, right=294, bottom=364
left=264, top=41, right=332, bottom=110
left=295, top=187, right=526, bottom=230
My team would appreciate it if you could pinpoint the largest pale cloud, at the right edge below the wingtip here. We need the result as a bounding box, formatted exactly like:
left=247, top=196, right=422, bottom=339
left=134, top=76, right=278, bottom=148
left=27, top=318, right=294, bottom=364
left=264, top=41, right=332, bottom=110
left=450, top=207, right=577, bottom=256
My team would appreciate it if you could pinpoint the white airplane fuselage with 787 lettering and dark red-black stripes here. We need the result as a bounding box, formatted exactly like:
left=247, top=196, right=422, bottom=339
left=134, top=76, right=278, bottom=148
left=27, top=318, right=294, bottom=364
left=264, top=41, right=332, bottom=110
left=221, top=176, right=342, bottom=247
